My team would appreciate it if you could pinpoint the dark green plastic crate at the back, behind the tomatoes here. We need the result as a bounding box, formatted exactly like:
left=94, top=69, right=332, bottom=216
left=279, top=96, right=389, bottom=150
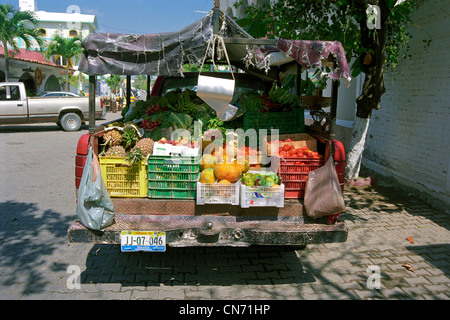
left=243, top=108, right=305, bottom=134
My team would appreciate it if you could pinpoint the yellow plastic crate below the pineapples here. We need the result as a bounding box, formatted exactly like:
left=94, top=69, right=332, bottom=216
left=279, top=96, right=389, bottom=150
left=99, top=157, right=147, bottom=198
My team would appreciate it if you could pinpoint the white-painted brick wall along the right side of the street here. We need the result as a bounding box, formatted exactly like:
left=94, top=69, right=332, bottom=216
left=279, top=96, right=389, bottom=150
left=363, top=0, right=450, bottom=210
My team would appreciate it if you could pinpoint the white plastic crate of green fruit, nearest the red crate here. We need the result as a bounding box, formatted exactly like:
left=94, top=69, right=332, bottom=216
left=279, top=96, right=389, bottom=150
left=241, top=184, right=284, bottom=208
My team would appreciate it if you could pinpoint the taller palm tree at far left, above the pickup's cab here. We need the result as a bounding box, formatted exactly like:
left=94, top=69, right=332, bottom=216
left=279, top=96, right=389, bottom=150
left=0, top=4, right=43, bottom=81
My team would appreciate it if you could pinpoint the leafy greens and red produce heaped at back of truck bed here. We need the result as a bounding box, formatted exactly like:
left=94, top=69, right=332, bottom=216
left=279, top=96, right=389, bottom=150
left=122, top=82, right=300, bottom=141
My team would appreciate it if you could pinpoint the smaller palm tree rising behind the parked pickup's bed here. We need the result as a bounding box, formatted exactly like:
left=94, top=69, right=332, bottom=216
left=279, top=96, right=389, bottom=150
left=45, top=34, right=83, bottom=91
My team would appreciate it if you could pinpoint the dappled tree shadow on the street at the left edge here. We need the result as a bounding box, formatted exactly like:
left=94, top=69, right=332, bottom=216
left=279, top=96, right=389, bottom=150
left=0, top=201, right=72, bottom=296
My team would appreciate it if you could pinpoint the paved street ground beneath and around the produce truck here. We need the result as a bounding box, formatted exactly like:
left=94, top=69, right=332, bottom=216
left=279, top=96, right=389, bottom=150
left=0, top=114, right=450, bottom=300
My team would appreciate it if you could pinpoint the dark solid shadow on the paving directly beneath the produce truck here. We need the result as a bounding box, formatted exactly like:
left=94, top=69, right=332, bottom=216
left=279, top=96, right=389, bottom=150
left=81, top=245, right=315, bottom=286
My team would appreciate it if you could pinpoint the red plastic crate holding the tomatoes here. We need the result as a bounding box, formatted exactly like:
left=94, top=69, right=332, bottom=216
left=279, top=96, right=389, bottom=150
left=278, top=158, right=323, bottom=199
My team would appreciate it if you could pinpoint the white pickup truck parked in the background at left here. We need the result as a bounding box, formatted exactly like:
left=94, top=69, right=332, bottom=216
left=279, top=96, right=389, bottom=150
left=0, top=82, right=106, bottom=131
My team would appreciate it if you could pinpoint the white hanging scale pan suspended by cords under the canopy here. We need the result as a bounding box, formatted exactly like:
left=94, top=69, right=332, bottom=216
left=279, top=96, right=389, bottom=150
left=197, top=36, right=238, bottom=121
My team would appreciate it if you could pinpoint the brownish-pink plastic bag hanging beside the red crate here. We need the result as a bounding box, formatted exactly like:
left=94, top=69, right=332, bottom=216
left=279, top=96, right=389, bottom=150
left=304, top=157, right=345, bottom=218
